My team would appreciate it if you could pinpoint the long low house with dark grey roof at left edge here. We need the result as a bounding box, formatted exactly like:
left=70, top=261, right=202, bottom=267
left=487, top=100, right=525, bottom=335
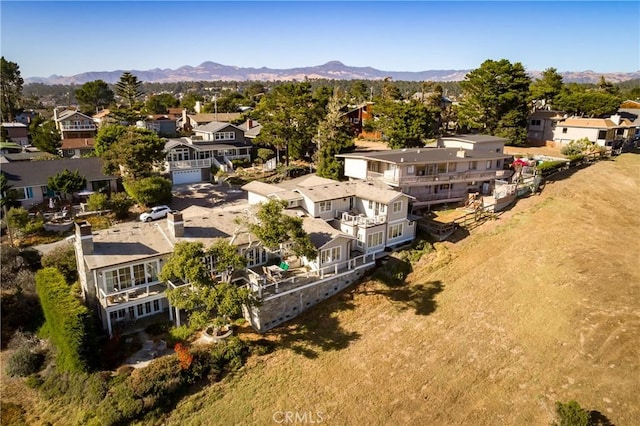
left=2, top=157, right=117, bottom=208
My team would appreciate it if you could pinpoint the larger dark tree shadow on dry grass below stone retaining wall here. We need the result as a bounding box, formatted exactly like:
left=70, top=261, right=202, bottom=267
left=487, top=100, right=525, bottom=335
left=270, top=291, right=360, bottom=359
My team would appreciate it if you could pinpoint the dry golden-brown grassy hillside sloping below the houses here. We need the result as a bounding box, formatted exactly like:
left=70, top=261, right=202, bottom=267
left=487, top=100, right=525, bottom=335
left=2, top=154, right=640, bottom=426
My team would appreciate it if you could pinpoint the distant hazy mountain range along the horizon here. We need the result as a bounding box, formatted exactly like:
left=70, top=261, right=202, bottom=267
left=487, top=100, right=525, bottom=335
left=24, top=61, right=640, bottom=84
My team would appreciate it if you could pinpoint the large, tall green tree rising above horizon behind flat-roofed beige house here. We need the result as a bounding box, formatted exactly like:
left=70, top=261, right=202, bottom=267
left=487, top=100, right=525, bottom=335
left=458, top=59, right=531, bottom=145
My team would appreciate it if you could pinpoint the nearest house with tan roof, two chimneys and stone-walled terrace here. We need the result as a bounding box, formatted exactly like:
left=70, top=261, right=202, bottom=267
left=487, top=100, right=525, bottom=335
left=74, top=174, right=390, bottom=335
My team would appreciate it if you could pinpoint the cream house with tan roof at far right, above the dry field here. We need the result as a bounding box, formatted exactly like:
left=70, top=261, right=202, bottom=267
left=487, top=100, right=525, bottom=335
left=553, top=114, right=637, bottom=148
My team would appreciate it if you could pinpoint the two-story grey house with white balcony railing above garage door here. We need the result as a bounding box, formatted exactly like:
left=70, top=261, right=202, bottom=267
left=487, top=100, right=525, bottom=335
left=165, top=122, right=253, bottom=185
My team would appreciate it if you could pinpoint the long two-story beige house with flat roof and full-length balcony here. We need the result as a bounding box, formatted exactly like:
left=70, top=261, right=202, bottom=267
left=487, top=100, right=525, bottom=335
left=337, top=135, right=511, bottom=210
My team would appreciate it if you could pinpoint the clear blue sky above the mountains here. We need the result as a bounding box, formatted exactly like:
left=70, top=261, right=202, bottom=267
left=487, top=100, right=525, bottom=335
left=0, top=0, right=640, bottom=78
